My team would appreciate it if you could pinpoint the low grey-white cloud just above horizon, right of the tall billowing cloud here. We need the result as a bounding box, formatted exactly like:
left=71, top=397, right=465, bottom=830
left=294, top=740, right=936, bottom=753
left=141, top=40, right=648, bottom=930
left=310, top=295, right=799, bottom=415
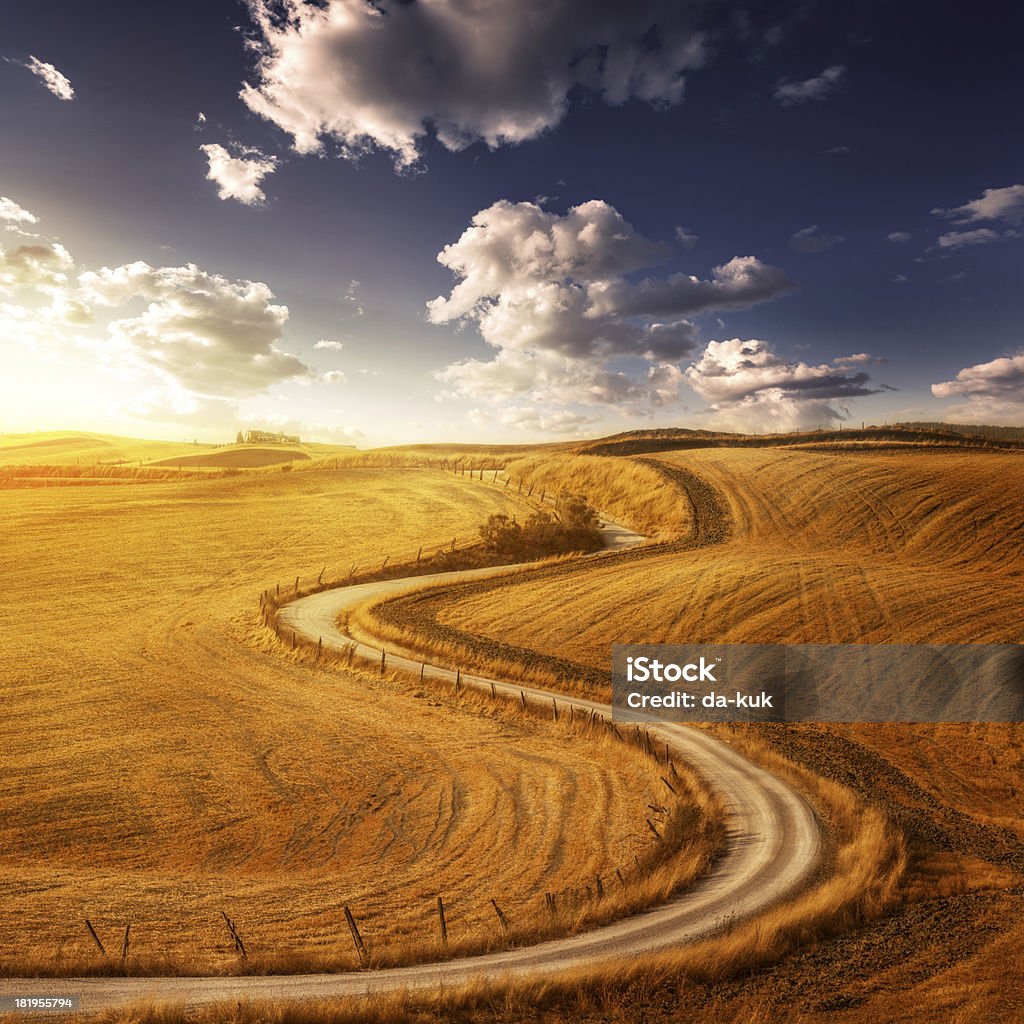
left=686, top=338, right=881, bottom=431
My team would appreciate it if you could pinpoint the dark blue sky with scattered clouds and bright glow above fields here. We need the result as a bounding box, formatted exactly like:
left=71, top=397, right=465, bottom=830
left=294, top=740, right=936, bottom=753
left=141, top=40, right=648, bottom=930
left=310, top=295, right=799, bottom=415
left=0, top=0, right=1024, bottom=446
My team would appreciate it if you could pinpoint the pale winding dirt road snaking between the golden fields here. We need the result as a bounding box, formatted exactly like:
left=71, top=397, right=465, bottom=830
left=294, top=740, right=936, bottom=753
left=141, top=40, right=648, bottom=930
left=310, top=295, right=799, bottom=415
left=0, top=524, right=821, bottom=1011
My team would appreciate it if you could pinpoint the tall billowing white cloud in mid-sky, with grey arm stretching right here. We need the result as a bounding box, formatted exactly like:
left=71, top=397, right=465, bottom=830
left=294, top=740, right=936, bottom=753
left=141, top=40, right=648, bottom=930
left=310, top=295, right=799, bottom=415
left=427, top=200, right=796, bottom=404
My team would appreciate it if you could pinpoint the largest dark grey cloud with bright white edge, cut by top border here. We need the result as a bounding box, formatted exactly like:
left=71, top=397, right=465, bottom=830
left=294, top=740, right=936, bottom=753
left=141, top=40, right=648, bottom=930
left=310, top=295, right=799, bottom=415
left=241, top=0, right=708, bottom=167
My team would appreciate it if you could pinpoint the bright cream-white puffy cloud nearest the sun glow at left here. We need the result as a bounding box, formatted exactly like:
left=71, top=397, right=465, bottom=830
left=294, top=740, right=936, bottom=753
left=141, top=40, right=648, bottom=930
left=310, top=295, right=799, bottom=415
left=79, top=262, right=311, bottom=396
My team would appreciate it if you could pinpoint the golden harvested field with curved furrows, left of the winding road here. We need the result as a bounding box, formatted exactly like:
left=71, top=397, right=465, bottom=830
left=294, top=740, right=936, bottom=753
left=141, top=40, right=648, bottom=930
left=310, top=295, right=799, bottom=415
left=0, top=469, right=688, bottom=974
